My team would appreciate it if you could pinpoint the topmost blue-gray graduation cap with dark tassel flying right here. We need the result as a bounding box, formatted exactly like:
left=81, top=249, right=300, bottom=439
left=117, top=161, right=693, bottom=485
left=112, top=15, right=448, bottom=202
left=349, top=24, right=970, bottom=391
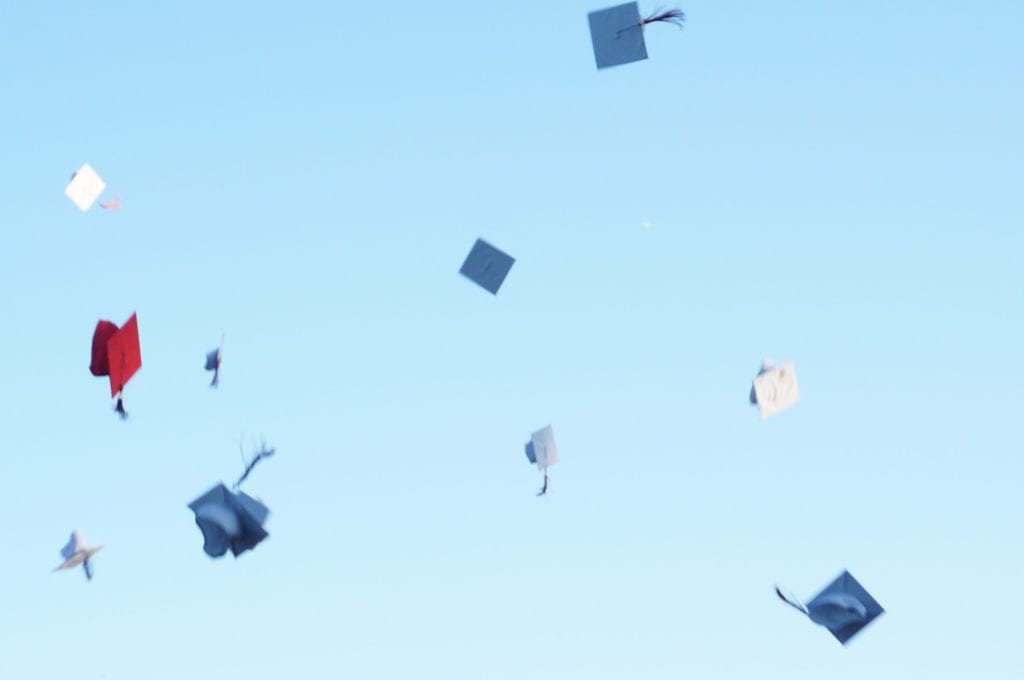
left=588, top=2, right=686, bottom=69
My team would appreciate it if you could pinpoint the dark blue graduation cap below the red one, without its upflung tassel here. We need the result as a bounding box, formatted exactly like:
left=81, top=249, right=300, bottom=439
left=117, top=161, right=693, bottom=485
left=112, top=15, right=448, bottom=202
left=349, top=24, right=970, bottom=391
left=188, top=483, right=270, bottom=557
